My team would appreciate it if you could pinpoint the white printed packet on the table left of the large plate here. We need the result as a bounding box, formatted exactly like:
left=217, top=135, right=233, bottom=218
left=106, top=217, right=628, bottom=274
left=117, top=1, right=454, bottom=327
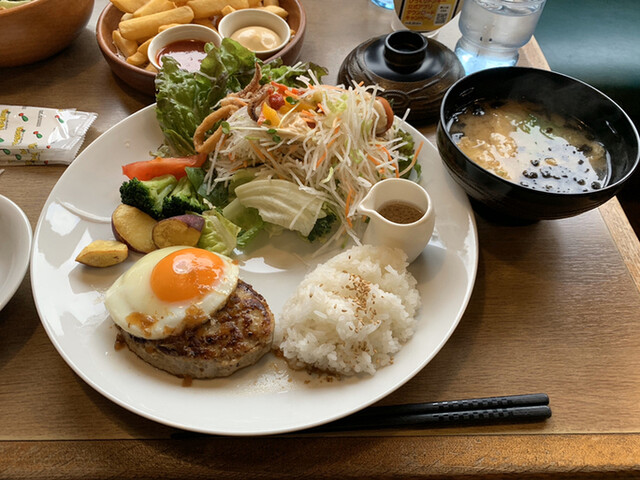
left=0, top=105, right=98, bottom=165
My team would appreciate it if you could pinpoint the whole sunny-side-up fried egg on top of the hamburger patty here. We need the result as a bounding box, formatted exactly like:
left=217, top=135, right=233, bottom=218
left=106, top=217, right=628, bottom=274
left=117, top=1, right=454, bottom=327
left=105, top=247, right=239, bottom=340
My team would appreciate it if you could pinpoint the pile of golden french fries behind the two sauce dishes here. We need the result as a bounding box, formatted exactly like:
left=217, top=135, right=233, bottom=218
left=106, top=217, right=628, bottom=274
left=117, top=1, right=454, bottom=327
left=111, top=0, right=288, bottom=72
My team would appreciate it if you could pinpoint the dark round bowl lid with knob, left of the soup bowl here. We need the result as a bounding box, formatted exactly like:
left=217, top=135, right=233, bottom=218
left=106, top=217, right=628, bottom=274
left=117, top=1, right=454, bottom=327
left=338, top=30, right=464, bottom=123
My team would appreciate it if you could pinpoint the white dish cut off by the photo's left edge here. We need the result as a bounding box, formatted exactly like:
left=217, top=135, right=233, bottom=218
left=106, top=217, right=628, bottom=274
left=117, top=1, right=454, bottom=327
left=0, top=195, right=32, bottom=310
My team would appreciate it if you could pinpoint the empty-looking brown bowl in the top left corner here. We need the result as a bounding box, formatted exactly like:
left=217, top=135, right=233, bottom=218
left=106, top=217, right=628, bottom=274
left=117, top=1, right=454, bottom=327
left=0, top=0, right=94, bottom=67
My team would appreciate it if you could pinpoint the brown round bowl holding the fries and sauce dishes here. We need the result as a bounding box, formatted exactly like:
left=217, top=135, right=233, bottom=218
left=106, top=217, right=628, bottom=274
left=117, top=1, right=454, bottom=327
left=96, top=0, right=307, bottom=95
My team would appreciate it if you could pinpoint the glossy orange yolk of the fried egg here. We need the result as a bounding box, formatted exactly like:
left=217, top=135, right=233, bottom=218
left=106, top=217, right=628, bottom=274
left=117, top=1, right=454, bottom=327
left=150, top=248, right=225, bottom=302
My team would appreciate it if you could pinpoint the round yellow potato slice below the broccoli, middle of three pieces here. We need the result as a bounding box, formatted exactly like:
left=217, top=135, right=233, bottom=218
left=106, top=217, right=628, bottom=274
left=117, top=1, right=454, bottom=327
left=111, top=204, right=158, bottom=253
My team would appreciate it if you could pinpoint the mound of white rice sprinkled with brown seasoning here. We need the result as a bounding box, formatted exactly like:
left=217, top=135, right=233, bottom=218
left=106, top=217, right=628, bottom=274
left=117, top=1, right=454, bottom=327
left=274, top=245, right=420, bottom=375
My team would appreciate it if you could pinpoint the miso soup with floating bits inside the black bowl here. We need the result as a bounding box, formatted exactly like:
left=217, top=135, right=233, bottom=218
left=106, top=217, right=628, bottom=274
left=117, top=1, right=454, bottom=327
left=449, top=100, right=611, bottom=193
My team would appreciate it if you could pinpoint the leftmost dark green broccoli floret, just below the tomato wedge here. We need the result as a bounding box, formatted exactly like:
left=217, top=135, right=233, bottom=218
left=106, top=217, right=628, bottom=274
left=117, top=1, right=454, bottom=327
left=120, top=175, right=178, bottom=219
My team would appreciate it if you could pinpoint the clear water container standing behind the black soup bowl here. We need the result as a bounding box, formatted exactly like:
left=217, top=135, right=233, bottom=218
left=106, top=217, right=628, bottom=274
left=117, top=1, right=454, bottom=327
left=455, top=0, right=546, bottom=74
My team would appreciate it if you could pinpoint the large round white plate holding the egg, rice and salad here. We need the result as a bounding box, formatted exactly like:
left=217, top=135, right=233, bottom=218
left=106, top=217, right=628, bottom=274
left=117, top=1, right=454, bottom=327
left=31, top=106, right=478, bottom=435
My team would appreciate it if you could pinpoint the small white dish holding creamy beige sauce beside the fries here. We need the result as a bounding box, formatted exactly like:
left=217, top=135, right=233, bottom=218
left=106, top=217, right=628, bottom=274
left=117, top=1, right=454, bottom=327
left=218, top=8, right=291, bottom=59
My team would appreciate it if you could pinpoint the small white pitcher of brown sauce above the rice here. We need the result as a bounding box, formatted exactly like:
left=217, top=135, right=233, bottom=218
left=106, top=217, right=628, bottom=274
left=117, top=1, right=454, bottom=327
left=358, top=178, right=436, bottom=263
